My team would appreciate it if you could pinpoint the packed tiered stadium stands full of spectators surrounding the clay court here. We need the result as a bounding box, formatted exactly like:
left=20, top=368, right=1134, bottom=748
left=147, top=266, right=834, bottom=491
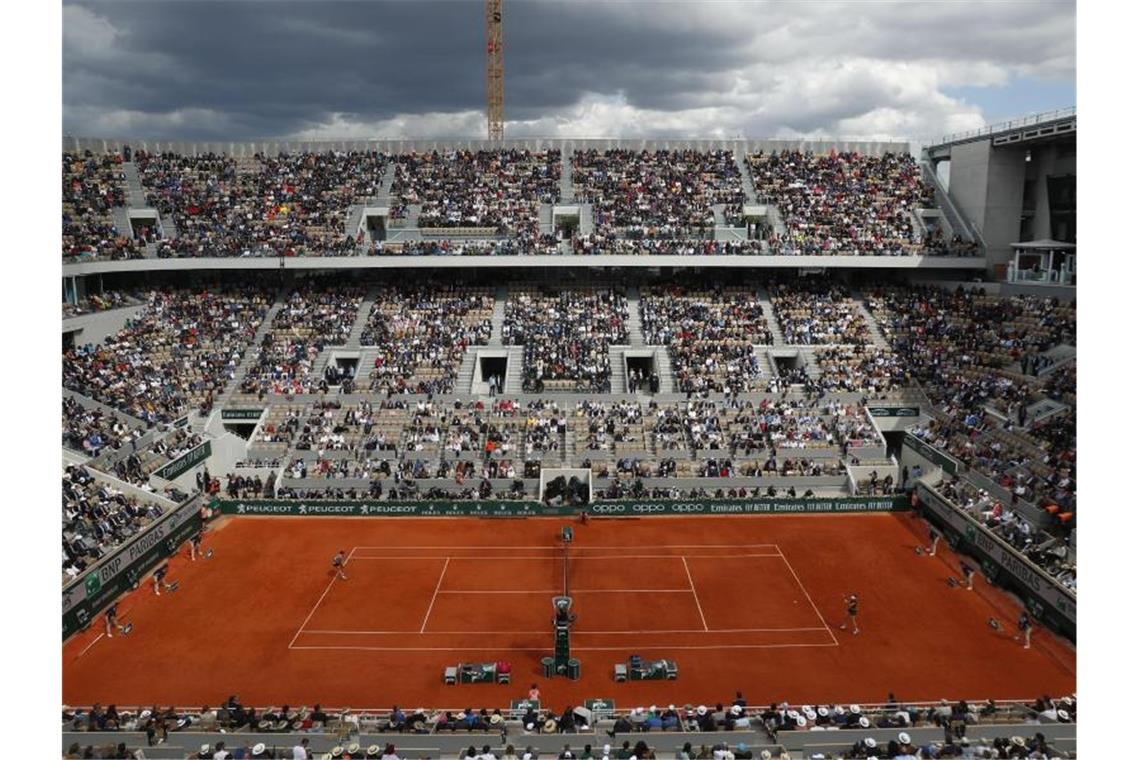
left=62, top=139, right=1076, bottom=760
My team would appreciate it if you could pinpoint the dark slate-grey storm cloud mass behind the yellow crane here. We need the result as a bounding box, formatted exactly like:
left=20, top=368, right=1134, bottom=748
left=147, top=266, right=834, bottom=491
left=64, top=1, right=746, bottom=139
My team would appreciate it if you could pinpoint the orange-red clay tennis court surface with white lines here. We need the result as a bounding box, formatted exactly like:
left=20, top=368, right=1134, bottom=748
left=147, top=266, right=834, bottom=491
left=63, top=514, right=1076, bottom=709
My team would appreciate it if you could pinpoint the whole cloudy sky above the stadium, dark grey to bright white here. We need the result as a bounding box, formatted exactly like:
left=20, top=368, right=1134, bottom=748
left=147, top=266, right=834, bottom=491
left=63, top=0, right=1076, bottom=140
